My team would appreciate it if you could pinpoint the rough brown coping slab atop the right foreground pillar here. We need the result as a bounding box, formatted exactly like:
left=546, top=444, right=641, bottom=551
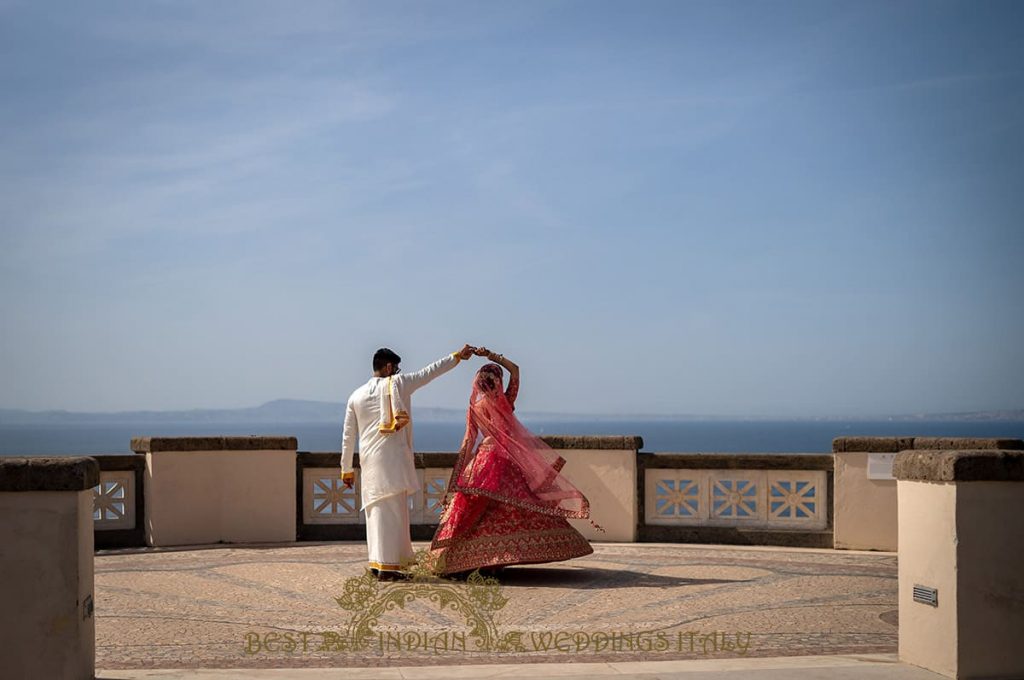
left=893, top=450, right=1024, bottom=481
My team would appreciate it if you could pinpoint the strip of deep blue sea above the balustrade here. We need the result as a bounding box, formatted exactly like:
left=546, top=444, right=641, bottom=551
left=0, top=419, right=1024, bottom=456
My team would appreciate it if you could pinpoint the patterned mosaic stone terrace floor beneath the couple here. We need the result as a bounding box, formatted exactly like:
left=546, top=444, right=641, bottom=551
left=95, top=543, right=897, bottom=670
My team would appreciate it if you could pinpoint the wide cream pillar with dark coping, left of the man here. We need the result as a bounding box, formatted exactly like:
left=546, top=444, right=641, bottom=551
left=131, top=436, right=298, bottom=546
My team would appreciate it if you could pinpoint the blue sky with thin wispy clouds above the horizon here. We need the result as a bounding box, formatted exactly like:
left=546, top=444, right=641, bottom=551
left=0, top=0, right=1024, bottom=418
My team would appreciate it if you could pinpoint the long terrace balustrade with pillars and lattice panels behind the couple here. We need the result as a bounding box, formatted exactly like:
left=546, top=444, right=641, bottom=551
left=72, top=435, right=1024, bottom=551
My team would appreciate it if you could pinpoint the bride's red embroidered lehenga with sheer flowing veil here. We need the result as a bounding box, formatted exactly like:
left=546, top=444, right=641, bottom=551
left=430, top=364, right=596, bottom=573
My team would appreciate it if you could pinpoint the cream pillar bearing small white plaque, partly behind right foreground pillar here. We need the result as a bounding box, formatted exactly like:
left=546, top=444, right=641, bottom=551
left=833, top=436, right=1024, bottom=550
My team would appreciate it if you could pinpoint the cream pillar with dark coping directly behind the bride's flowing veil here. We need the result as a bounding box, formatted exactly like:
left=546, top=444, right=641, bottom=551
left=542, top=435, right=643, bottom=543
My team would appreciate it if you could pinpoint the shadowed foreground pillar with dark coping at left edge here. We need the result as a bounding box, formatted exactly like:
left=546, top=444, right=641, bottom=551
left=0, top=457, right=99, bottom=680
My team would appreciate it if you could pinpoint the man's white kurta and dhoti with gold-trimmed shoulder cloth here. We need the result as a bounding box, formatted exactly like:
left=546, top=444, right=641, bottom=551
left=341, top=354, right=460, bottom=568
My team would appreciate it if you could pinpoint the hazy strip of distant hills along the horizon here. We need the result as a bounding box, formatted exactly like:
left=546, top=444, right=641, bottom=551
left=0, top=399, right=1024, bottom=425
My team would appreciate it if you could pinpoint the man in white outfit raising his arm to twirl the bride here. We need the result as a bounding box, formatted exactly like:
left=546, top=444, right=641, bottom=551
left=341, top=345, right=475, bottom=581
